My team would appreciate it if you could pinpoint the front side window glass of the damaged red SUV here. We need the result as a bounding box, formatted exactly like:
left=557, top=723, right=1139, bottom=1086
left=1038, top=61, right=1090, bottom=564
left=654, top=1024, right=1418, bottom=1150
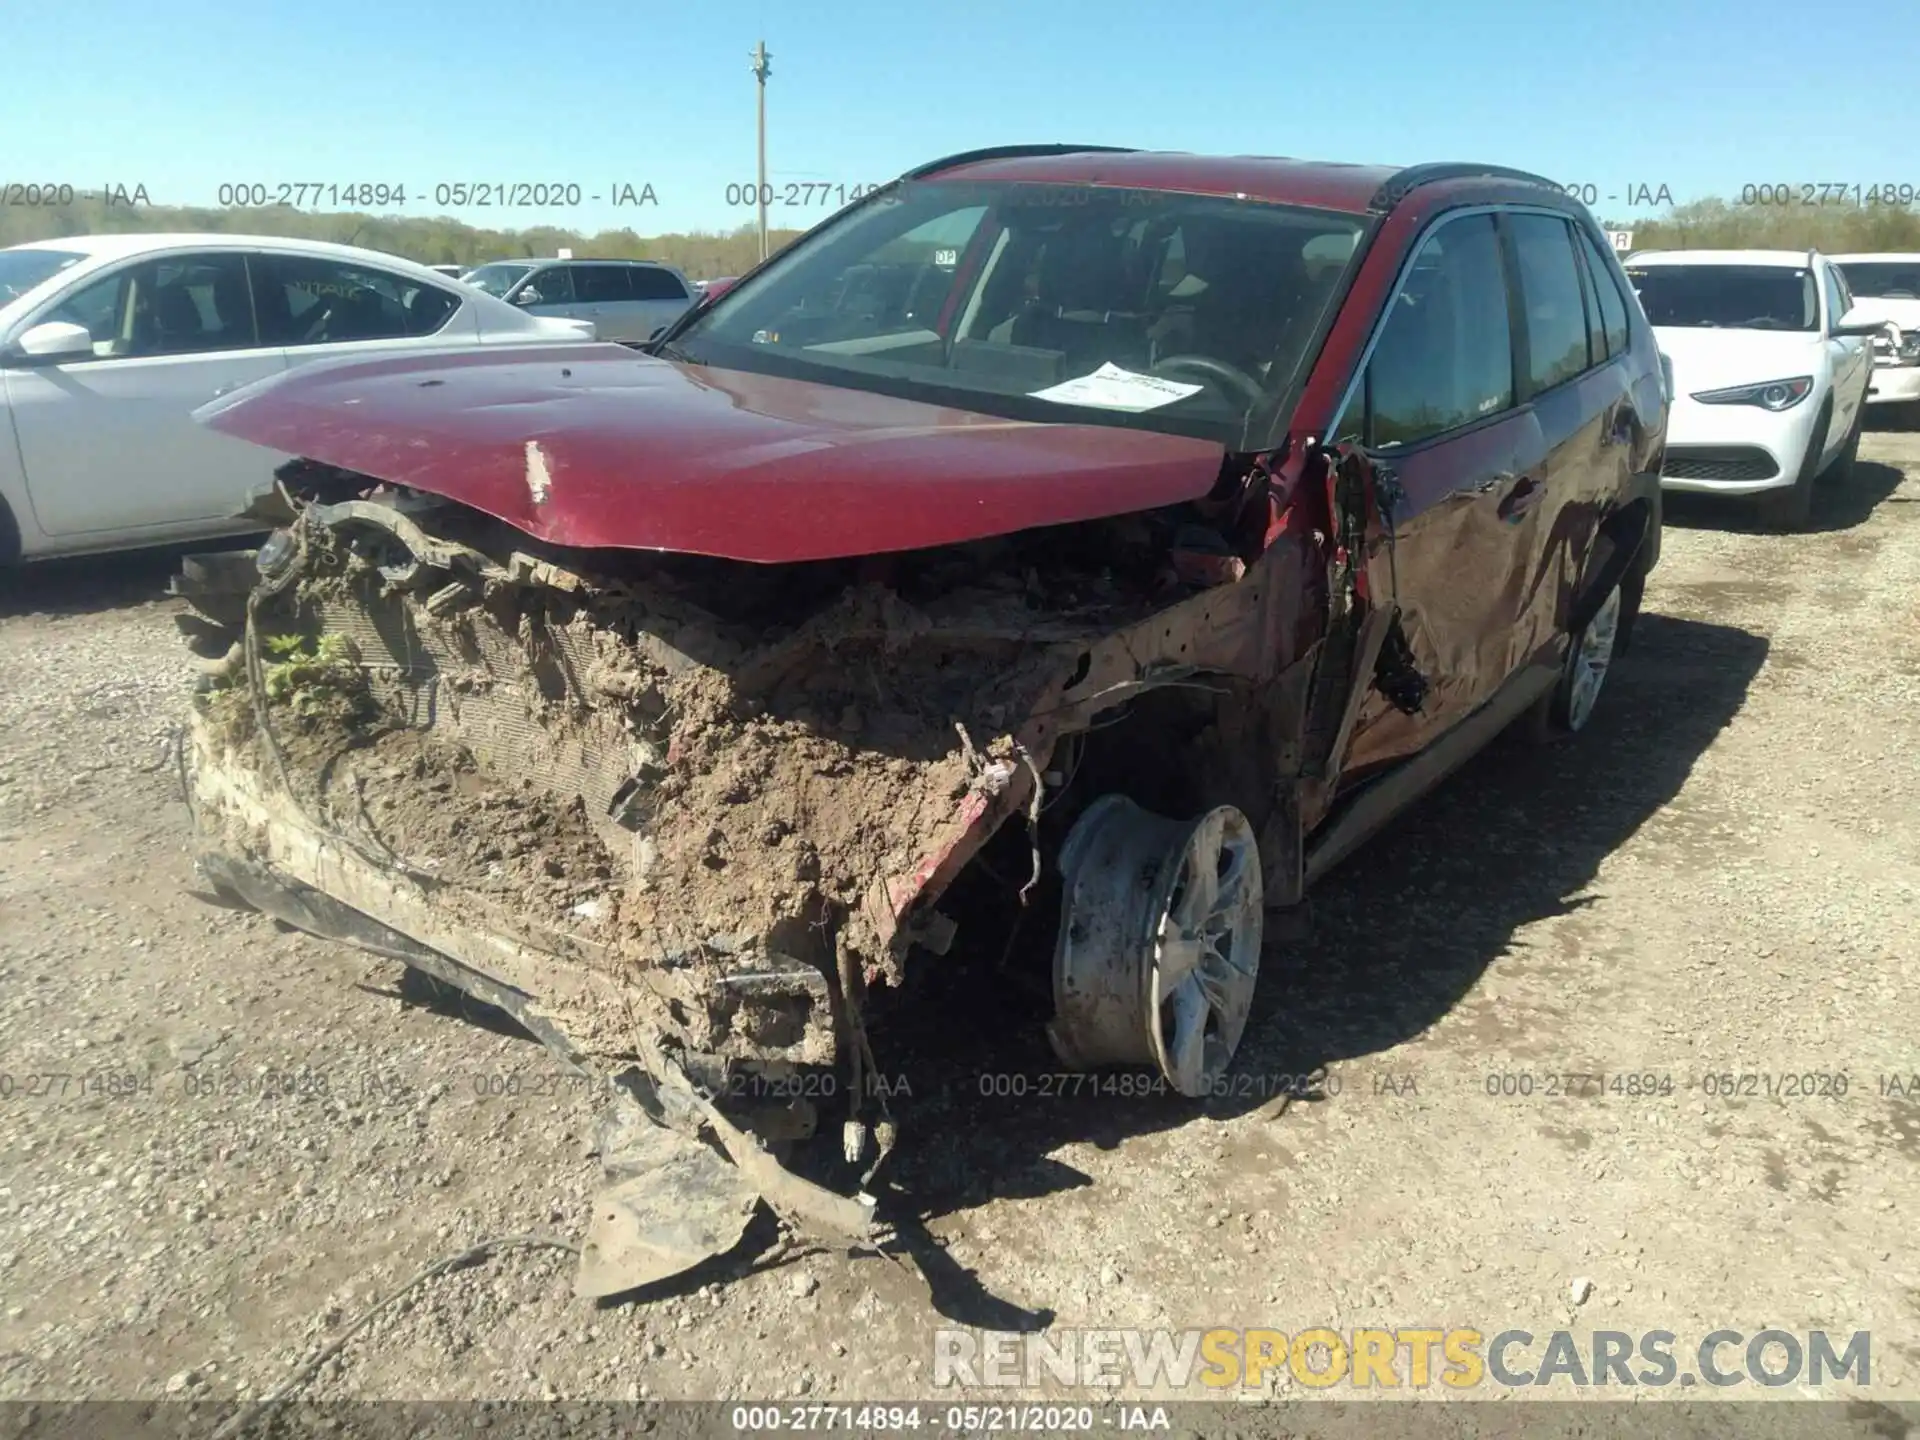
left=1367, top=215, right=1512, bottom=445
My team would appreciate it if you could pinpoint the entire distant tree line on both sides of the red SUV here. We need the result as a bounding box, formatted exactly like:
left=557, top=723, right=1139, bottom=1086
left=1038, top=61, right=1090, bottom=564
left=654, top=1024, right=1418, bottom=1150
left=0, top=198, right=1920, bottom=280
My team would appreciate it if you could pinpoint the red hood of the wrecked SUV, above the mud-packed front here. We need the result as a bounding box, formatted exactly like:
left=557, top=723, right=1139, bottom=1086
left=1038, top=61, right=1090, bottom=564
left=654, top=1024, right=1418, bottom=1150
left=196, top=346, right=1225, bottom=563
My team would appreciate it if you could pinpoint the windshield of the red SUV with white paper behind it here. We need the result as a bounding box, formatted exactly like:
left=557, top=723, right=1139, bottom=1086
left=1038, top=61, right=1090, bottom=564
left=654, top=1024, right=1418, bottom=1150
left=668, top=180, right=1363, bottom=445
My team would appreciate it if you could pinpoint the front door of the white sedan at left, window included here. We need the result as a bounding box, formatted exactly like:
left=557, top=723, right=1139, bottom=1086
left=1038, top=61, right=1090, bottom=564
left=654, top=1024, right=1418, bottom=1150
left=4, top=252, right=286, bottom=536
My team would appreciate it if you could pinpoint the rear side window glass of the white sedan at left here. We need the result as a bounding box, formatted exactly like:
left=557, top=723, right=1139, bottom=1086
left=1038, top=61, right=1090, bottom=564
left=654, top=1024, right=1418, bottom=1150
left=250, top=255, right=461, bottom=346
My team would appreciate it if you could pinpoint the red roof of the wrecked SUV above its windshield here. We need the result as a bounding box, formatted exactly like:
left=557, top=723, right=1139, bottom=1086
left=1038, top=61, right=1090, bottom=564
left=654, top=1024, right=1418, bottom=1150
left=916, top=150, right=1402, bottom=215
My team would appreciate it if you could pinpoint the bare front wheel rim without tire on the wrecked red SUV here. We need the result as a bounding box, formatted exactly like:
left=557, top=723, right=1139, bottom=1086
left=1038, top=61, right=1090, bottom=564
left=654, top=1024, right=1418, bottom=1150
left=1048, top=795, right=1265, bottom=1096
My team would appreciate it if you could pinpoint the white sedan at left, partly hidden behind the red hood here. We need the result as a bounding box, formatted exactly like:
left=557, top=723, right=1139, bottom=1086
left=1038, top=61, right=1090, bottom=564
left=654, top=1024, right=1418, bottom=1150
left=0, top=234, right=593, bottom=564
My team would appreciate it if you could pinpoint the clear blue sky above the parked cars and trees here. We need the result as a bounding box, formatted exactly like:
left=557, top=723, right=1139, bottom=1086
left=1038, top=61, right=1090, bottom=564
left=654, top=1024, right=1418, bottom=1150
left=0, top=0, right=1920, bottom=232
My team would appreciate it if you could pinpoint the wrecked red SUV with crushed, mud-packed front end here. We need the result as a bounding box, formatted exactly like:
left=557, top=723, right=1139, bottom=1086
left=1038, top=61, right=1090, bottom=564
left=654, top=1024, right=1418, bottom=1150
left=182, top=146, right=1667, bottom=1274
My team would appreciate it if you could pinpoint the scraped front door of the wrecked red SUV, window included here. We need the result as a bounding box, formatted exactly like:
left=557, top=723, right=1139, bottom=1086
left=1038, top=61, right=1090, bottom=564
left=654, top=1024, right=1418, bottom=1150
left=1334, top=209, right=1548, bottom=780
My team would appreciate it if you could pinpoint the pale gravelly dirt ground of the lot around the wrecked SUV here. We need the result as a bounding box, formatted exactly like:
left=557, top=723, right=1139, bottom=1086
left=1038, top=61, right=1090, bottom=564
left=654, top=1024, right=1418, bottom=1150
left=0, top=434, right=1920, bottom=1400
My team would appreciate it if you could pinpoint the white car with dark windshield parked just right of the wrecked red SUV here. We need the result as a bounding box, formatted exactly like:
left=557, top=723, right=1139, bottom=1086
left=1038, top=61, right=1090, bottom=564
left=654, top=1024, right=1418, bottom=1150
left=1626, top=250, right=1884, bottom=530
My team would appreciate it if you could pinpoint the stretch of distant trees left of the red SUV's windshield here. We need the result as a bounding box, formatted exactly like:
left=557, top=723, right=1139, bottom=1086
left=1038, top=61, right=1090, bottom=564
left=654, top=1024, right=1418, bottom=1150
left=0, top=196, right=801, bottom=280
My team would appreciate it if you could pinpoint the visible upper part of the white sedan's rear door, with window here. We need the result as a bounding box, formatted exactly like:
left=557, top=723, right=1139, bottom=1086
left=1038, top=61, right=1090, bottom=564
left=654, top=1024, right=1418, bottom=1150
left=252, top=252, right=480, bottom=365
